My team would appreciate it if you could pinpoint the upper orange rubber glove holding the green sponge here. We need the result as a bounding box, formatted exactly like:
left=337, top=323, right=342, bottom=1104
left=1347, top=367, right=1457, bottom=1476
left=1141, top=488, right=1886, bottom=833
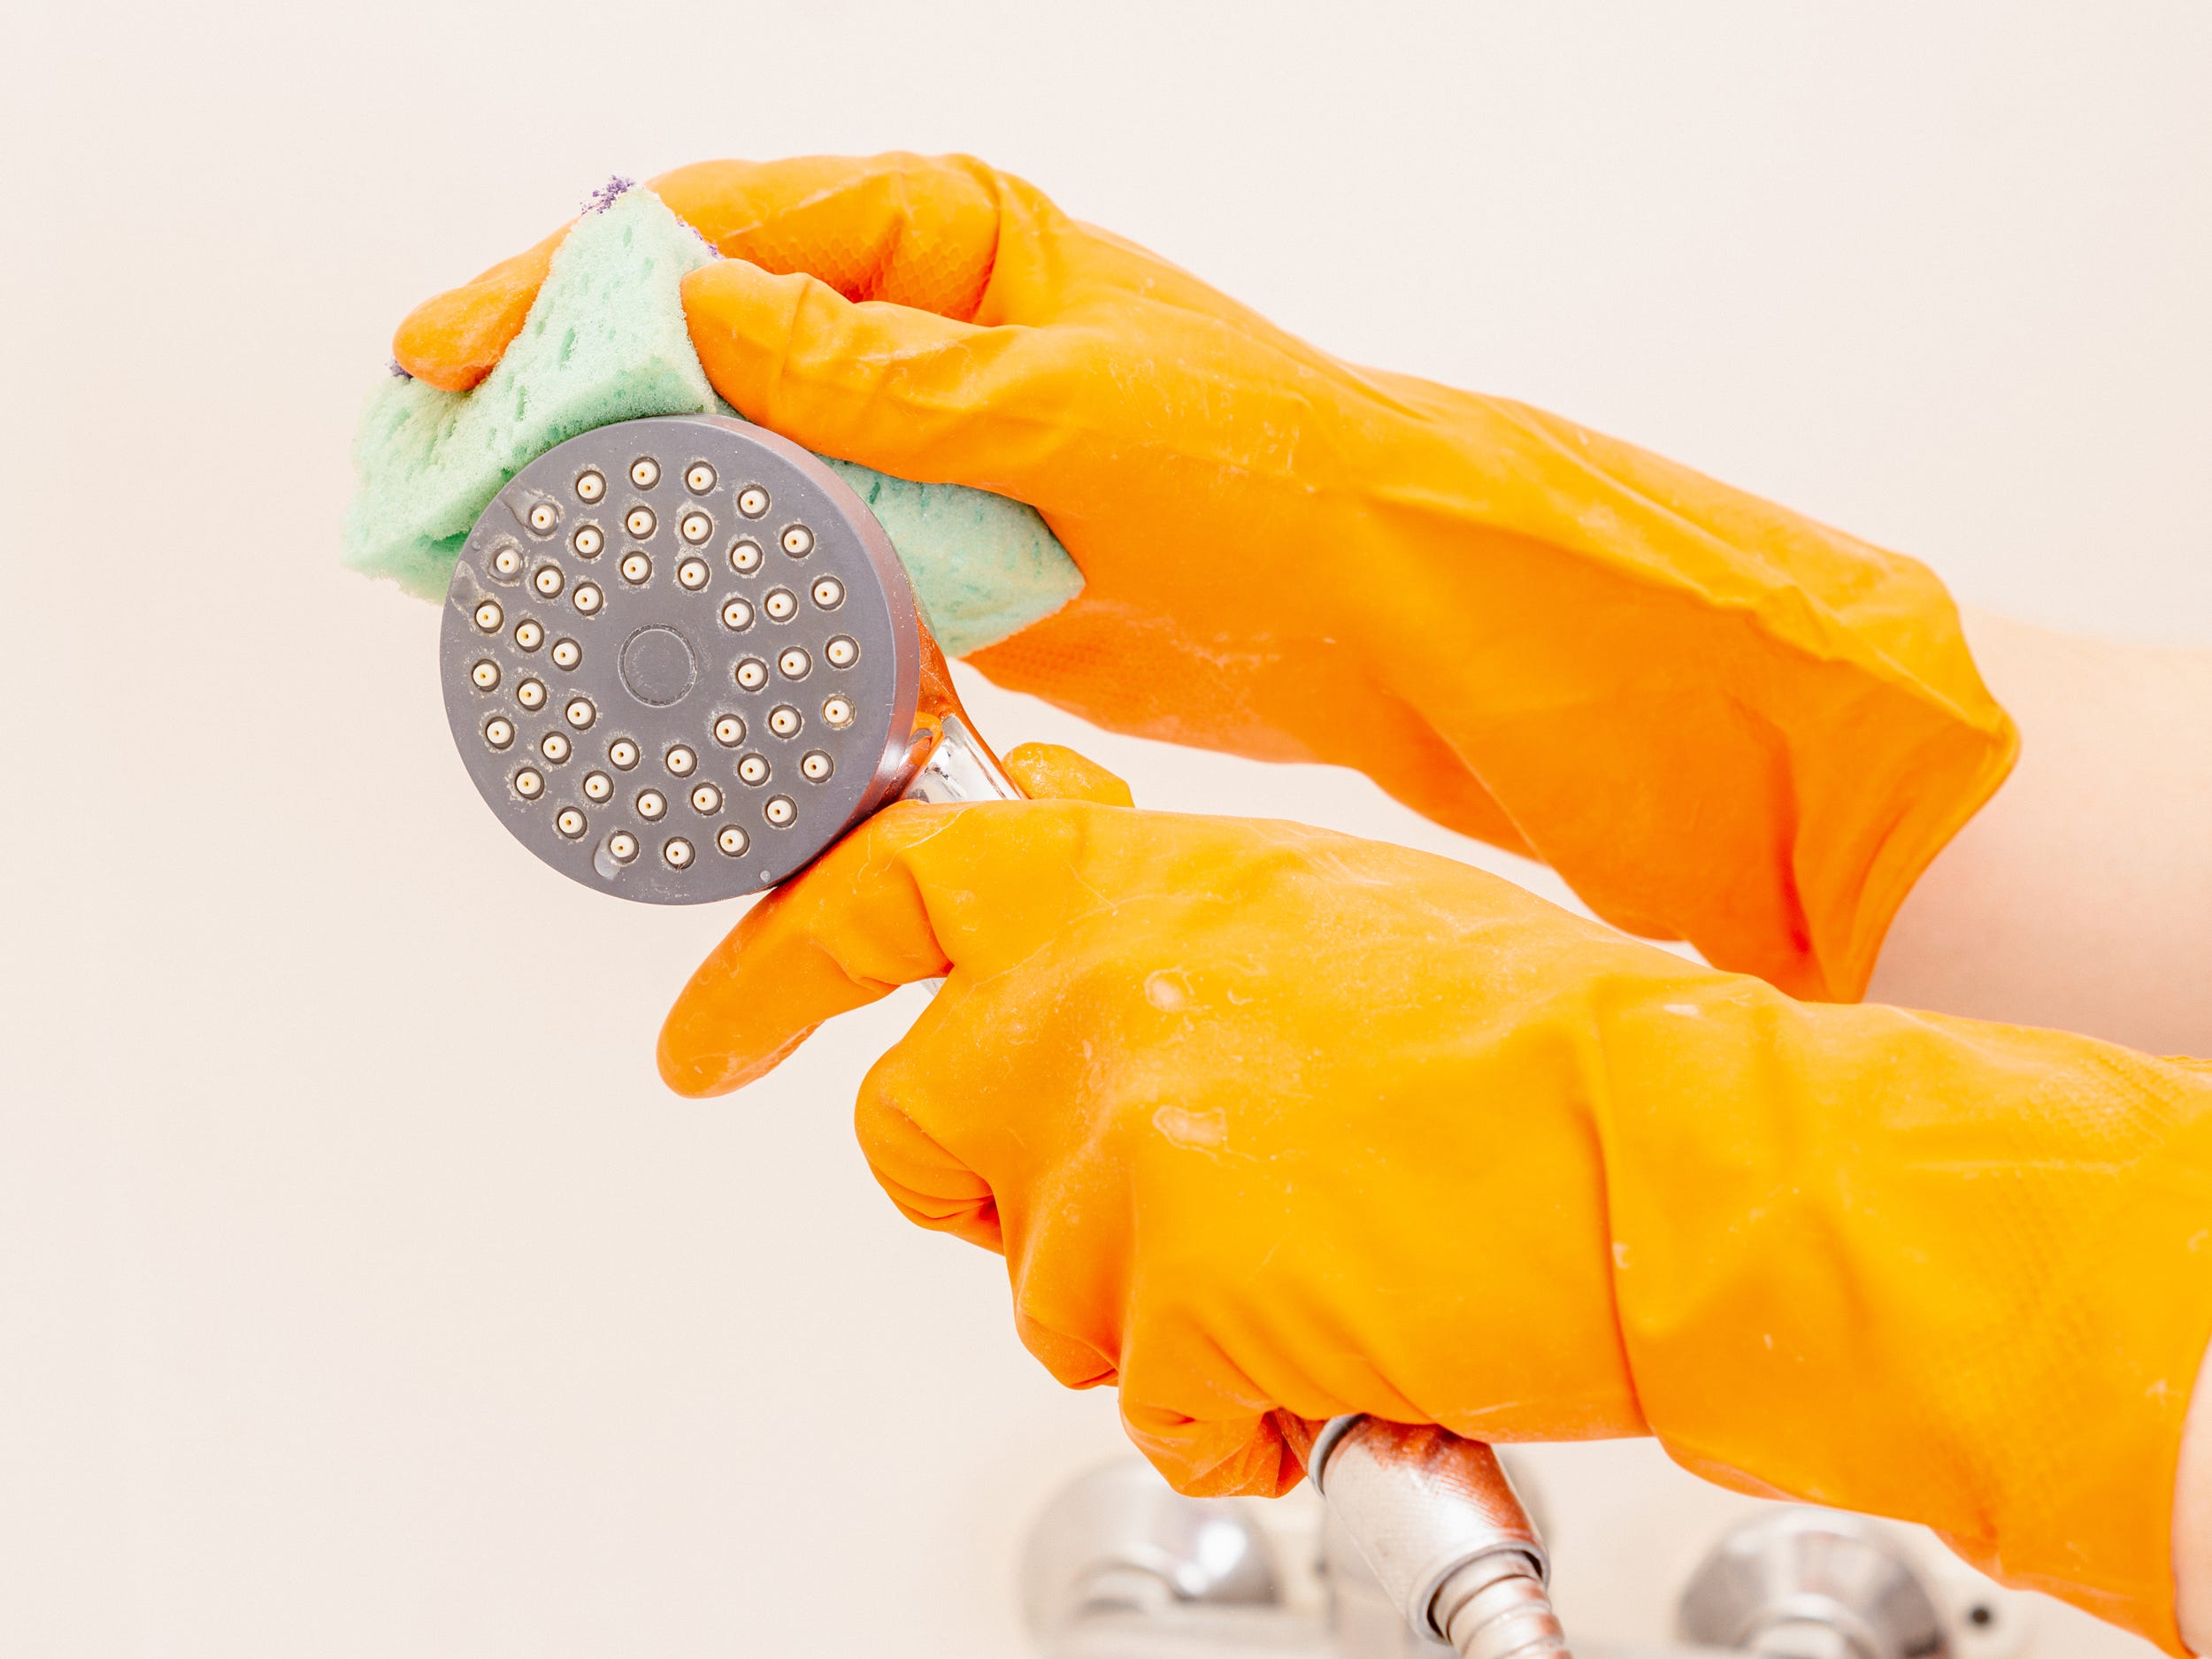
left=394, top=155, right=2016, bottom=998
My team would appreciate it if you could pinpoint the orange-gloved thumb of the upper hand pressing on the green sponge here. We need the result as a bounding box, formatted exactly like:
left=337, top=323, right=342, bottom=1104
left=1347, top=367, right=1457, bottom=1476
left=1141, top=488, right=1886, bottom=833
left=684, top=259, right=1095, bottom=500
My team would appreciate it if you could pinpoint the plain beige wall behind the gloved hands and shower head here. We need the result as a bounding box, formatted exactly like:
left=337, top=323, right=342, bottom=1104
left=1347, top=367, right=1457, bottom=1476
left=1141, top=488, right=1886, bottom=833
left=0, top=0, right=2212, bottom=1659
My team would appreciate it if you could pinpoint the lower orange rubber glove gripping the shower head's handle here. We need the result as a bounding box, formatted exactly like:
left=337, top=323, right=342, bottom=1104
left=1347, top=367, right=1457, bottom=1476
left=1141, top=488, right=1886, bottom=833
left=659, top=801, right=2212, bottom=1646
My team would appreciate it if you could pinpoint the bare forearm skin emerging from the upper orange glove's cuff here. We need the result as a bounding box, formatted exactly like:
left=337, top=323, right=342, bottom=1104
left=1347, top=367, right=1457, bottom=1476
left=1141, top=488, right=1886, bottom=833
left=1870, top=613, right=2212, bottom=1056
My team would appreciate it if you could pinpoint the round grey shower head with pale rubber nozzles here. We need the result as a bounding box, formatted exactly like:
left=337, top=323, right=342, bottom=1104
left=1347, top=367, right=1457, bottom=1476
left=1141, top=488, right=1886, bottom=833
left=438, top=416, right=923, bottom=905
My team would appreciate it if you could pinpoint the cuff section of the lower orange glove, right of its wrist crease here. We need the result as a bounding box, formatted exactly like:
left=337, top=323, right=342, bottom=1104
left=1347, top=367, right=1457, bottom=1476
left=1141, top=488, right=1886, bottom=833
left=1606, top=980, right=2212, bottom=1653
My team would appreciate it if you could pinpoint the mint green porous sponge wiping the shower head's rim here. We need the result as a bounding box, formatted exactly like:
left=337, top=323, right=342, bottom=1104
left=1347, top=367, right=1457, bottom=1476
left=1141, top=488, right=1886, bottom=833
left=343, top=188, right=1084, bottom=657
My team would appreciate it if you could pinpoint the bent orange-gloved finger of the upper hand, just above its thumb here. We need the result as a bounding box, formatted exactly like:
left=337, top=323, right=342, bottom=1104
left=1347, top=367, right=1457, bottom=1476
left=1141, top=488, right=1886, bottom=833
left=650, top=150, right=1009, bottom=321
